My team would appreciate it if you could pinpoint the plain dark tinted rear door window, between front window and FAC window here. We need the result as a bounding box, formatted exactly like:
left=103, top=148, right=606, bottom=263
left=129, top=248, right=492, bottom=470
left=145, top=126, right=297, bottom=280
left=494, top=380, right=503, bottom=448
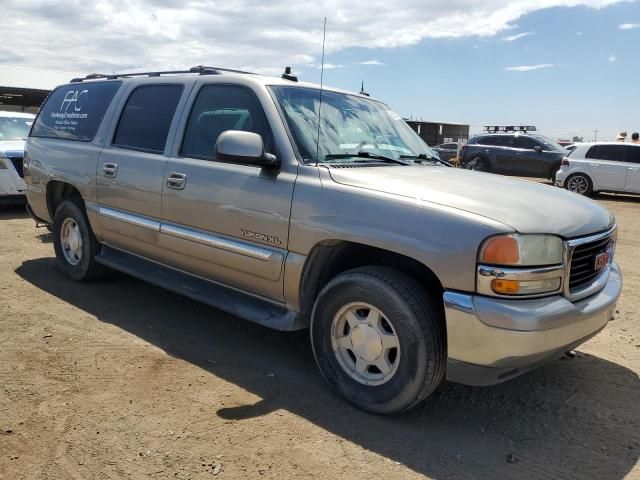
left=113, top=85, right=183, bottom=153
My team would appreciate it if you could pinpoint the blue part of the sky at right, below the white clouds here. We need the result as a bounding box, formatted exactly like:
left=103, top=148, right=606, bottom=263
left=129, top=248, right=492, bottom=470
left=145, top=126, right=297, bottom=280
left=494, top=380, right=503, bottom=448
left=303, top=1, right=640, bottom=140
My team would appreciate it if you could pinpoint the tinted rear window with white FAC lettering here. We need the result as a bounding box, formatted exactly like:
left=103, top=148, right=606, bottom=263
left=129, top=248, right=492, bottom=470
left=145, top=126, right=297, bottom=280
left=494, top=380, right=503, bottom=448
left=30, top=82, right=122, bottom=142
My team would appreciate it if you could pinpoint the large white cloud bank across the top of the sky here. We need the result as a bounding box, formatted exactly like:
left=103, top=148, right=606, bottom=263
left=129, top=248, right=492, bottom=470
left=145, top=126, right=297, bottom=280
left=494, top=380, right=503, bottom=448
left=0, top=0, right=623, bottom=73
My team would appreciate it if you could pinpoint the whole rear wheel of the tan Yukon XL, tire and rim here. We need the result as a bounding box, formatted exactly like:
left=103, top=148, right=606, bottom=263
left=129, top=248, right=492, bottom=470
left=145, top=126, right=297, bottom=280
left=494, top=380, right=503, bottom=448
left=52, top=200, right=105, bottom=281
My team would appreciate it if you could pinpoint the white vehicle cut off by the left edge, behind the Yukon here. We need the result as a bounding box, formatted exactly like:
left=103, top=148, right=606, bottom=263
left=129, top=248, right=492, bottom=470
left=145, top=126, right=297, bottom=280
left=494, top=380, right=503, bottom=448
left=0, top=111, right=36, bottom=200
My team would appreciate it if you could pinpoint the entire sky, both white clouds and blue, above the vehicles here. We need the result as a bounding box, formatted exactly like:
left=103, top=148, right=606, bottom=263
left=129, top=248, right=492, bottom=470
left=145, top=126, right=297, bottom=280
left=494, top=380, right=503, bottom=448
left=6, top=0, right=640, bottom=139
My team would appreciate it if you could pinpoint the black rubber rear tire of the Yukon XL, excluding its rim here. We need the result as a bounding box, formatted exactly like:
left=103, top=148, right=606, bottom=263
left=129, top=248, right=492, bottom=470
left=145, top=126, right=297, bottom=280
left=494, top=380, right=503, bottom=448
left=53, top=201, right=95, bottom=280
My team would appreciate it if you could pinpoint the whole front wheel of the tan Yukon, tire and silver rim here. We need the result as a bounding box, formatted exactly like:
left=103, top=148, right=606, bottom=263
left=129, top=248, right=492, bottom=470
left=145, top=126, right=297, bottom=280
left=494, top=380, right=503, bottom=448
left=311, top=267, right=447, bottom=414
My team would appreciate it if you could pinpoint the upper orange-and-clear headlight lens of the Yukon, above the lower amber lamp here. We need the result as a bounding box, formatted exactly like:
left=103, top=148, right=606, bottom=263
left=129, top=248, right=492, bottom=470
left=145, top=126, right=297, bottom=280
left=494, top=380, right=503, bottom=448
left=479, top=234, right=563, bottom=266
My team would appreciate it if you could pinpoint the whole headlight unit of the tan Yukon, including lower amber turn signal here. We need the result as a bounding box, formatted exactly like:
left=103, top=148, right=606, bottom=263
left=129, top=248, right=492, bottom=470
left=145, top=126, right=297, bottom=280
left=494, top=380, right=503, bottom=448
left=477, top=234, right=565, bottom=297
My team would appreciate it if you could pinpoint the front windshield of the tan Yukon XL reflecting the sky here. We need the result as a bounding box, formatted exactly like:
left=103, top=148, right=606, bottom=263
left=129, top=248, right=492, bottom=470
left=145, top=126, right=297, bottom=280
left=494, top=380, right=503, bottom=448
left=270, top=86, right=437, bottom=162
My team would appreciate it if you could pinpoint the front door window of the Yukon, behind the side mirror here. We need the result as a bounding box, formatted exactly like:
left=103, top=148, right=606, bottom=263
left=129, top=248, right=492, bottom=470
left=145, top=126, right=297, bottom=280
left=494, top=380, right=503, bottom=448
left=180, top=85, right=276, bottom=160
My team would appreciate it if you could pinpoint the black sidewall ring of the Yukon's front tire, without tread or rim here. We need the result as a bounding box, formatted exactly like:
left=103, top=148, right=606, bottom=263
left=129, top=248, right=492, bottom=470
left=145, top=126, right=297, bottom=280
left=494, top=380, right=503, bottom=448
left=311, top=273, right=433, bottom=413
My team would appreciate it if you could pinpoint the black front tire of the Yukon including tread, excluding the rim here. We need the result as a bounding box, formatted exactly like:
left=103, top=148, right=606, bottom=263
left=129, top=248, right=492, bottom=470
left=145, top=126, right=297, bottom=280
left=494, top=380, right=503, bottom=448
left=311, top=266, right=447, bottom=414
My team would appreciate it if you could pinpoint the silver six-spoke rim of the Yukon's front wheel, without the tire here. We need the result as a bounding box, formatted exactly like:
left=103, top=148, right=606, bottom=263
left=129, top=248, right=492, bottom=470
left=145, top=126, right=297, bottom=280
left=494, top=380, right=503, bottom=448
left=331, top=302, right=400, bottom=385
